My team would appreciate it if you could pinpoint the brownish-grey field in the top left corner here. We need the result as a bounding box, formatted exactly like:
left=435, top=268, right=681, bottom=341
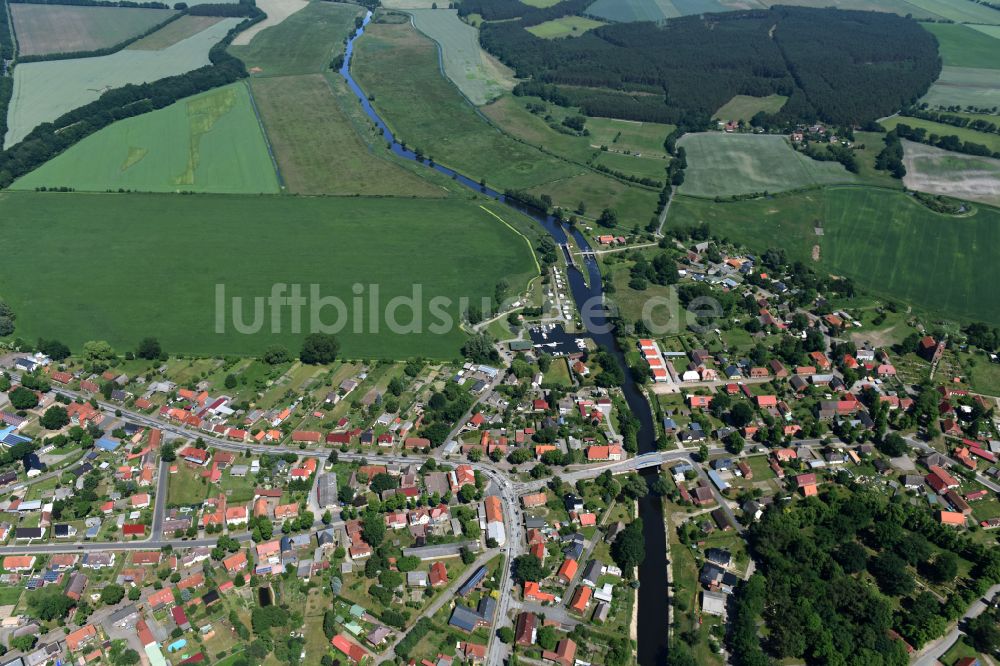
left=10, top=3, right=177, bottom=56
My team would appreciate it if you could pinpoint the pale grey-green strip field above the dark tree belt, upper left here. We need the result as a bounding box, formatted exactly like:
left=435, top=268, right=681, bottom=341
left=4, top=19, right=240, bottom=147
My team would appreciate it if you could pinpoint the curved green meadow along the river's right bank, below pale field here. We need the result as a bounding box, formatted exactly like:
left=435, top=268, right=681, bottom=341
left=351, top=24, right=582, bottom=190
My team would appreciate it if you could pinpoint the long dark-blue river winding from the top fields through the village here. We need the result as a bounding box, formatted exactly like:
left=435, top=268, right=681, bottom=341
left=340, top=12, right=667, bottom=666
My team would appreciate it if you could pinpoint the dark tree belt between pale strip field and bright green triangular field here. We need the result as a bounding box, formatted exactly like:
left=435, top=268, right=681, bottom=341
left=0, top=3, right=266, bottom=188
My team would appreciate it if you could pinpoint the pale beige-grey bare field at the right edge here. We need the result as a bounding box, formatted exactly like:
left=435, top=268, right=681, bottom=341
left=903, top=141, right=1000, bottom=206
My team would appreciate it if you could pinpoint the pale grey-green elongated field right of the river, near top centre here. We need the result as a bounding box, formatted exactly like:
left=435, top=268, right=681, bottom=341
left=410, top=9, right=514, bottom=106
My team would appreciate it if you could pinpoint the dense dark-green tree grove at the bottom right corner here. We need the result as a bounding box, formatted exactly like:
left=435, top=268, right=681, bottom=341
left=729, top=486, right=1000, bottom=666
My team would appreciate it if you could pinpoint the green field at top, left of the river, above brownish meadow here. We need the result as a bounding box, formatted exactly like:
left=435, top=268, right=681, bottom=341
left=229, top=2, right=362, bottom=76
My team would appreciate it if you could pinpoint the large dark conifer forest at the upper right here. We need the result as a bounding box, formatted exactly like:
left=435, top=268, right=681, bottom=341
left=474, top=0, right=941, bottom=125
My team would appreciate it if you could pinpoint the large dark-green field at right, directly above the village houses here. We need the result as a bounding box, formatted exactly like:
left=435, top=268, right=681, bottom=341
left=668, top=186, right=1000, bottom=325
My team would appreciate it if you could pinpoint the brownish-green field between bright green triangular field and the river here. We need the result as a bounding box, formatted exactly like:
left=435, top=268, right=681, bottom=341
left=251, top=74, right=445, bottom=197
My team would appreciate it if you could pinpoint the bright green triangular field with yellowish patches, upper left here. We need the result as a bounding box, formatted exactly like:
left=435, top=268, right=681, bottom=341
left=13, top=83, right=278, bottom=194
